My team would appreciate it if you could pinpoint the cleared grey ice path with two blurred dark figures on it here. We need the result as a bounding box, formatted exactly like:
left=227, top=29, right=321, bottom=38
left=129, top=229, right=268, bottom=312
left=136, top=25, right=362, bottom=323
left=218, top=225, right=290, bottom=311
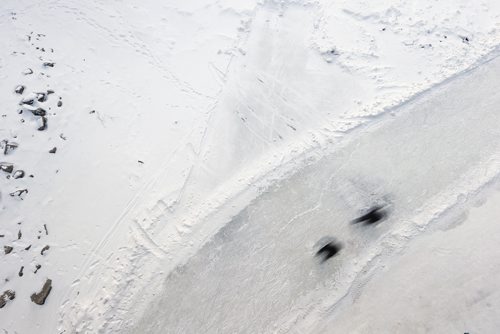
left=133, top=58, right=500, bottom=333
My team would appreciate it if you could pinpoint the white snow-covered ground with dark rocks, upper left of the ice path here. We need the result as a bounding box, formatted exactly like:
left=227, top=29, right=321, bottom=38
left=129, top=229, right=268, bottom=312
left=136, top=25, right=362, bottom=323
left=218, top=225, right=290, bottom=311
left=0, top=0, right=500, bottom=333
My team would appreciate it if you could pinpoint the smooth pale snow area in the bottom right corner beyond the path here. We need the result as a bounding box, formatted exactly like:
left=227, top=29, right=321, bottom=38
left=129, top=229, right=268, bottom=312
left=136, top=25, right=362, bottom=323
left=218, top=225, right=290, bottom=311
left=310, top=187, right=500, bottom=334
